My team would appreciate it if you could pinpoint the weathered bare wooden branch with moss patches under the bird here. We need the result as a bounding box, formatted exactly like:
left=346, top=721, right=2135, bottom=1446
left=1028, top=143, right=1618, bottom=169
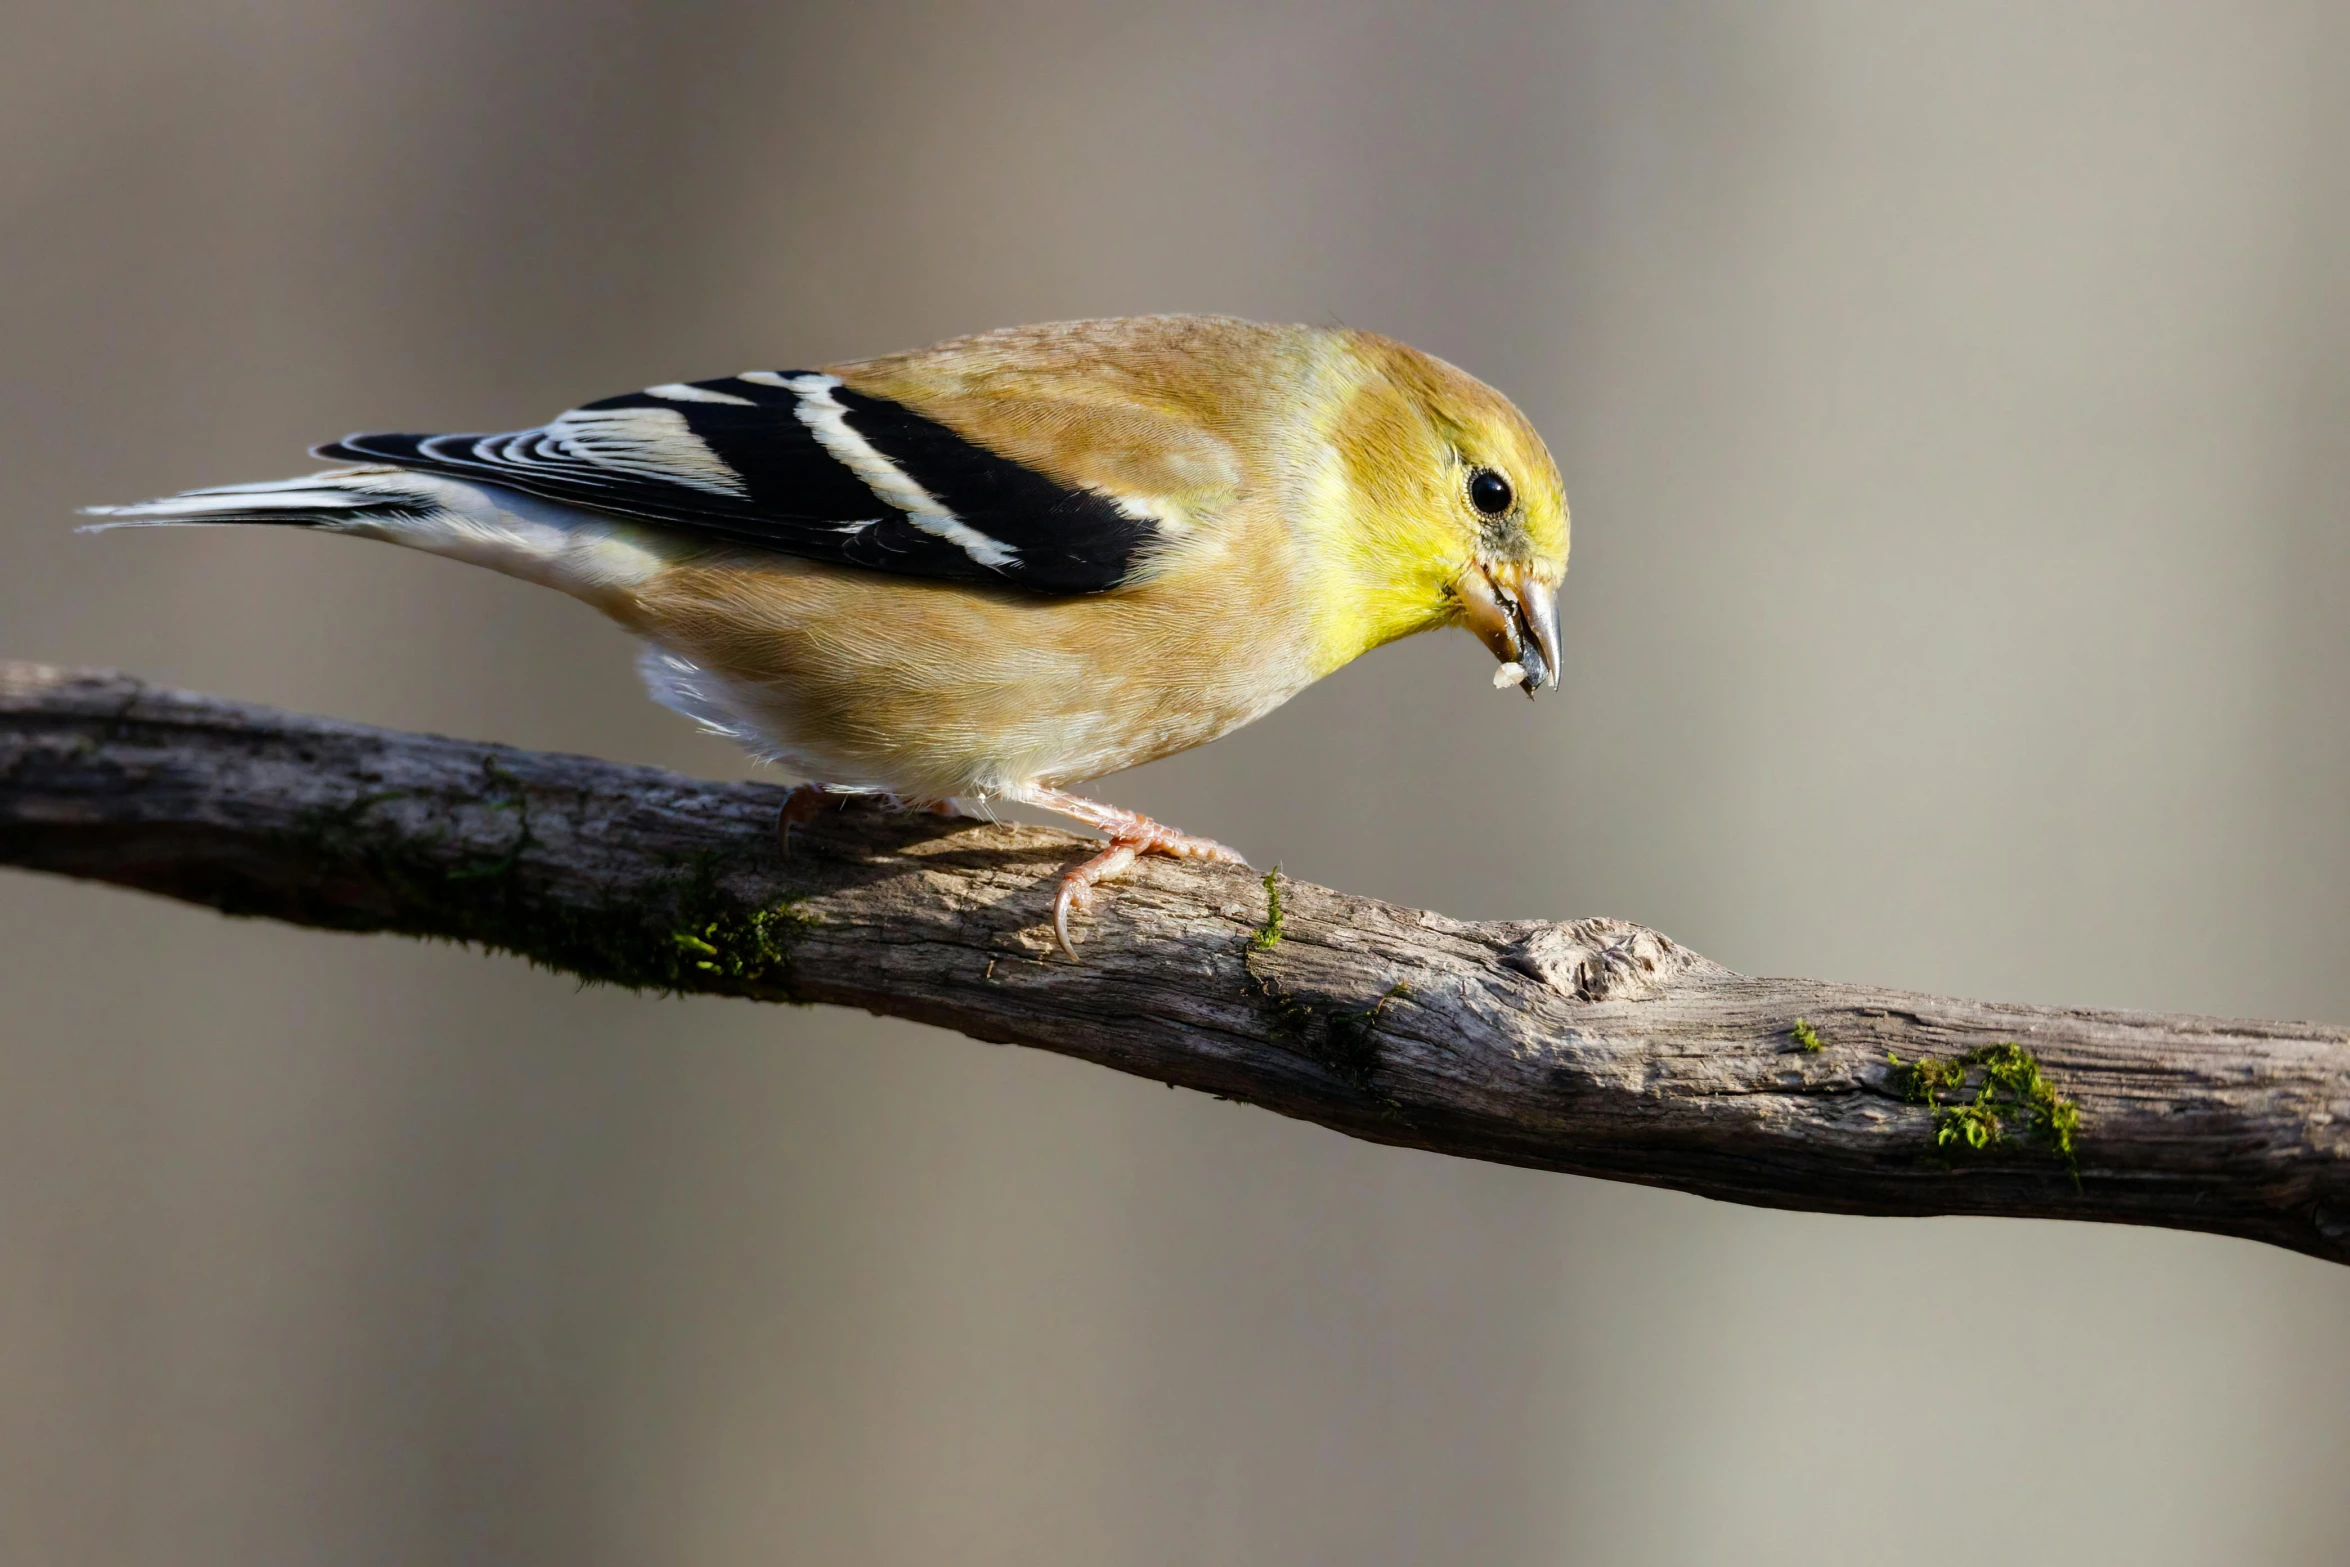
left=0, top=665, right=2350, bottom=1262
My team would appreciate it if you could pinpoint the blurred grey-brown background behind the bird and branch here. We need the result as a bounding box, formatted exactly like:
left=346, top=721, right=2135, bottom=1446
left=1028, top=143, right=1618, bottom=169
left=0, top=0, right=2350, bottom=1565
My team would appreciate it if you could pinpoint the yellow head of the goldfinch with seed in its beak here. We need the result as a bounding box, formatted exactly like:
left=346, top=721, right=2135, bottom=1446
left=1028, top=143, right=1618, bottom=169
left=1316, top=331, right=1567, bottom=695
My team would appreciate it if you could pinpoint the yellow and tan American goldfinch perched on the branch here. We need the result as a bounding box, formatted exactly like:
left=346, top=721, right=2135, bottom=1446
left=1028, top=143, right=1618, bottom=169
left=89, top=315, right=1567, bottom=956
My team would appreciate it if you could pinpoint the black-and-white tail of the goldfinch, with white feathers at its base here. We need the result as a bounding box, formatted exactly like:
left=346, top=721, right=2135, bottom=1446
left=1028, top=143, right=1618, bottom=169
left=82, top=468, right=670, bottom=597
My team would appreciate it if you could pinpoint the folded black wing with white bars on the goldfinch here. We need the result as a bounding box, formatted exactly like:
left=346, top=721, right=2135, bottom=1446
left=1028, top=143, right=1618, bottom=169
left=317, top=371, right=1154, bottom=594
